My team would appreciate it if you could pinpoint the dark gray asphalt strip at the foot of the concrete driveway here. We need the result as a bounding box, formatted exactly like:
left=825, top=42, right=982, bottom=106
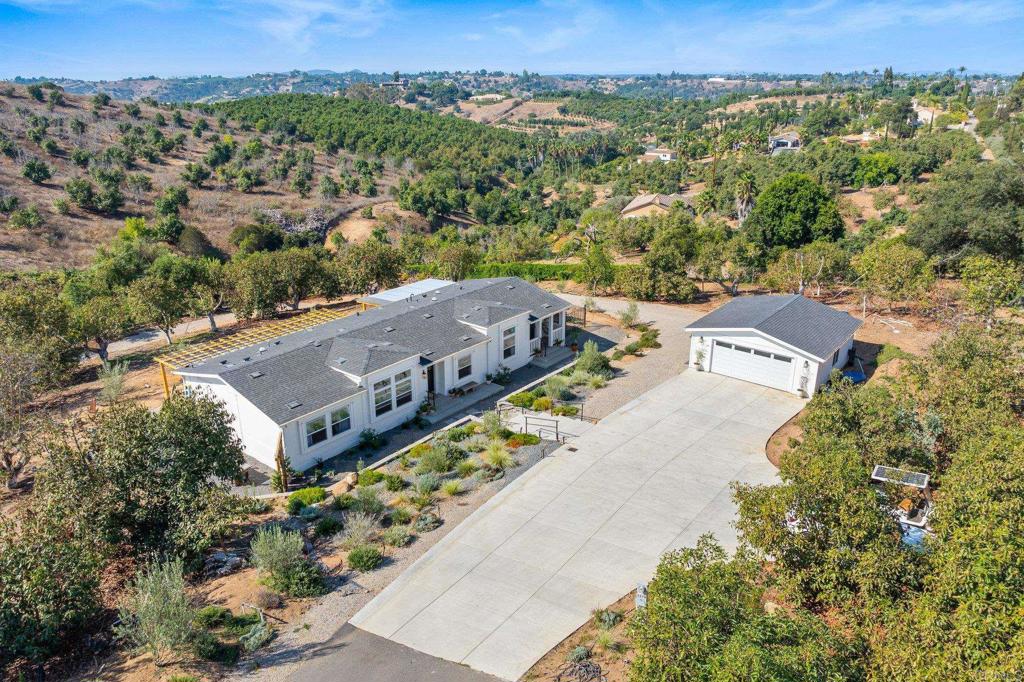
left=289, top=624, right=500, bottom=682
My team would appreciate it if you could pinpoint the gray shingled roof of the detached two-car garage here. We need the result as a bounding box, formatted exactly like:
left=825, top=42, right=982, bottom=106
left=686, top=294, right=862, bottom=359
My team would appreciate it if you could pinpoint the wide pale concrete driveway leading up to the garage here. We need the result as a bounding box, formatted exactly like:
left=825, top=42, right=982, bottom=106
left=351, top=371, right=804, bottom=680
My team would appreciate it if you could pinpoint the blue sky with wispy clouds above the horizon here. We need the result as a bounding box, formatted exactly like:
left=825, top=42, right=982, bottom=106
left=0, top=0, right=1024, bottom=79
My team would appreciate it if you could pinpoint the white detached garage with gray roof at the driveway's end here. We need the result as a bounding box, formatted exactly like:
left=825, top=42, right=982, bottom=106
left=686, top=295, right=861, bottom=397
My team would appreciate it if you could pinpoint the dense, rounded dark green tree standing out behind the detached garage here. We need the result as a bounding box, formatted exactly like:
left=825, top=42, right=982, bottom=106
left=743, top=173, right=843, bottom=251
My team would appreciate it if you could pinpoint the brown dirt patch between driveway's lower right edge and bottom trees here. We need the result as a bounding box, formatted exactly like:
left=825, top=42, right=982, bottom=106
left=521, top=591, right=636, bottom=682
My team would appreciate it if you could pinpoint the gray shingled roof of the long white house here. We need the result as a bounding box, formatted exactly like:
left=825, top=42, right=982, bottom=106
left=178, top=278, right=569, bottom=424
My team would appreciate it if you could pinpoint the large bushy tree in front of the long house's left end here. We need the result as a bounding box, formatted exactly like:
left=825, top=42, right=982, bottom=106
left=37, top=395, right=244, bottom=566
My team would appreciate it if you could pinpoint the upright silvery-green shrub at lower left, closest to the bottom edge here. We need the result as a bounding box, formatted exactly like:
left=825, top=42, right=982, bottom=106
left=115, top=559, right=199, bottom=662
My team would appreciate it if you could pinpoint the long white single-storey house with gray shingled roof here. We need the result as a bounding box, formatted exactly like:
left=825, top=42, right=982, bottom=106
left=174, top=278, right=569, bottom=470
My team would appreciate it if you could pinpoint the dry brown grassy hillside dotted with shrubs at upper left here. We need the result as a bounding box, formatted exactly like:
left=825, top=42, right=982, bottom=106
left=0, top=88, right=400, bottom=270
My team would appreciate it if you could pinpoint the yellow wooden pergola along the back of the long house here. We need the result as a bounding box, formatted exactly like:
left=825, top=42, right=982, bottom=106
left=149, top=303, right=367, bottom=398
